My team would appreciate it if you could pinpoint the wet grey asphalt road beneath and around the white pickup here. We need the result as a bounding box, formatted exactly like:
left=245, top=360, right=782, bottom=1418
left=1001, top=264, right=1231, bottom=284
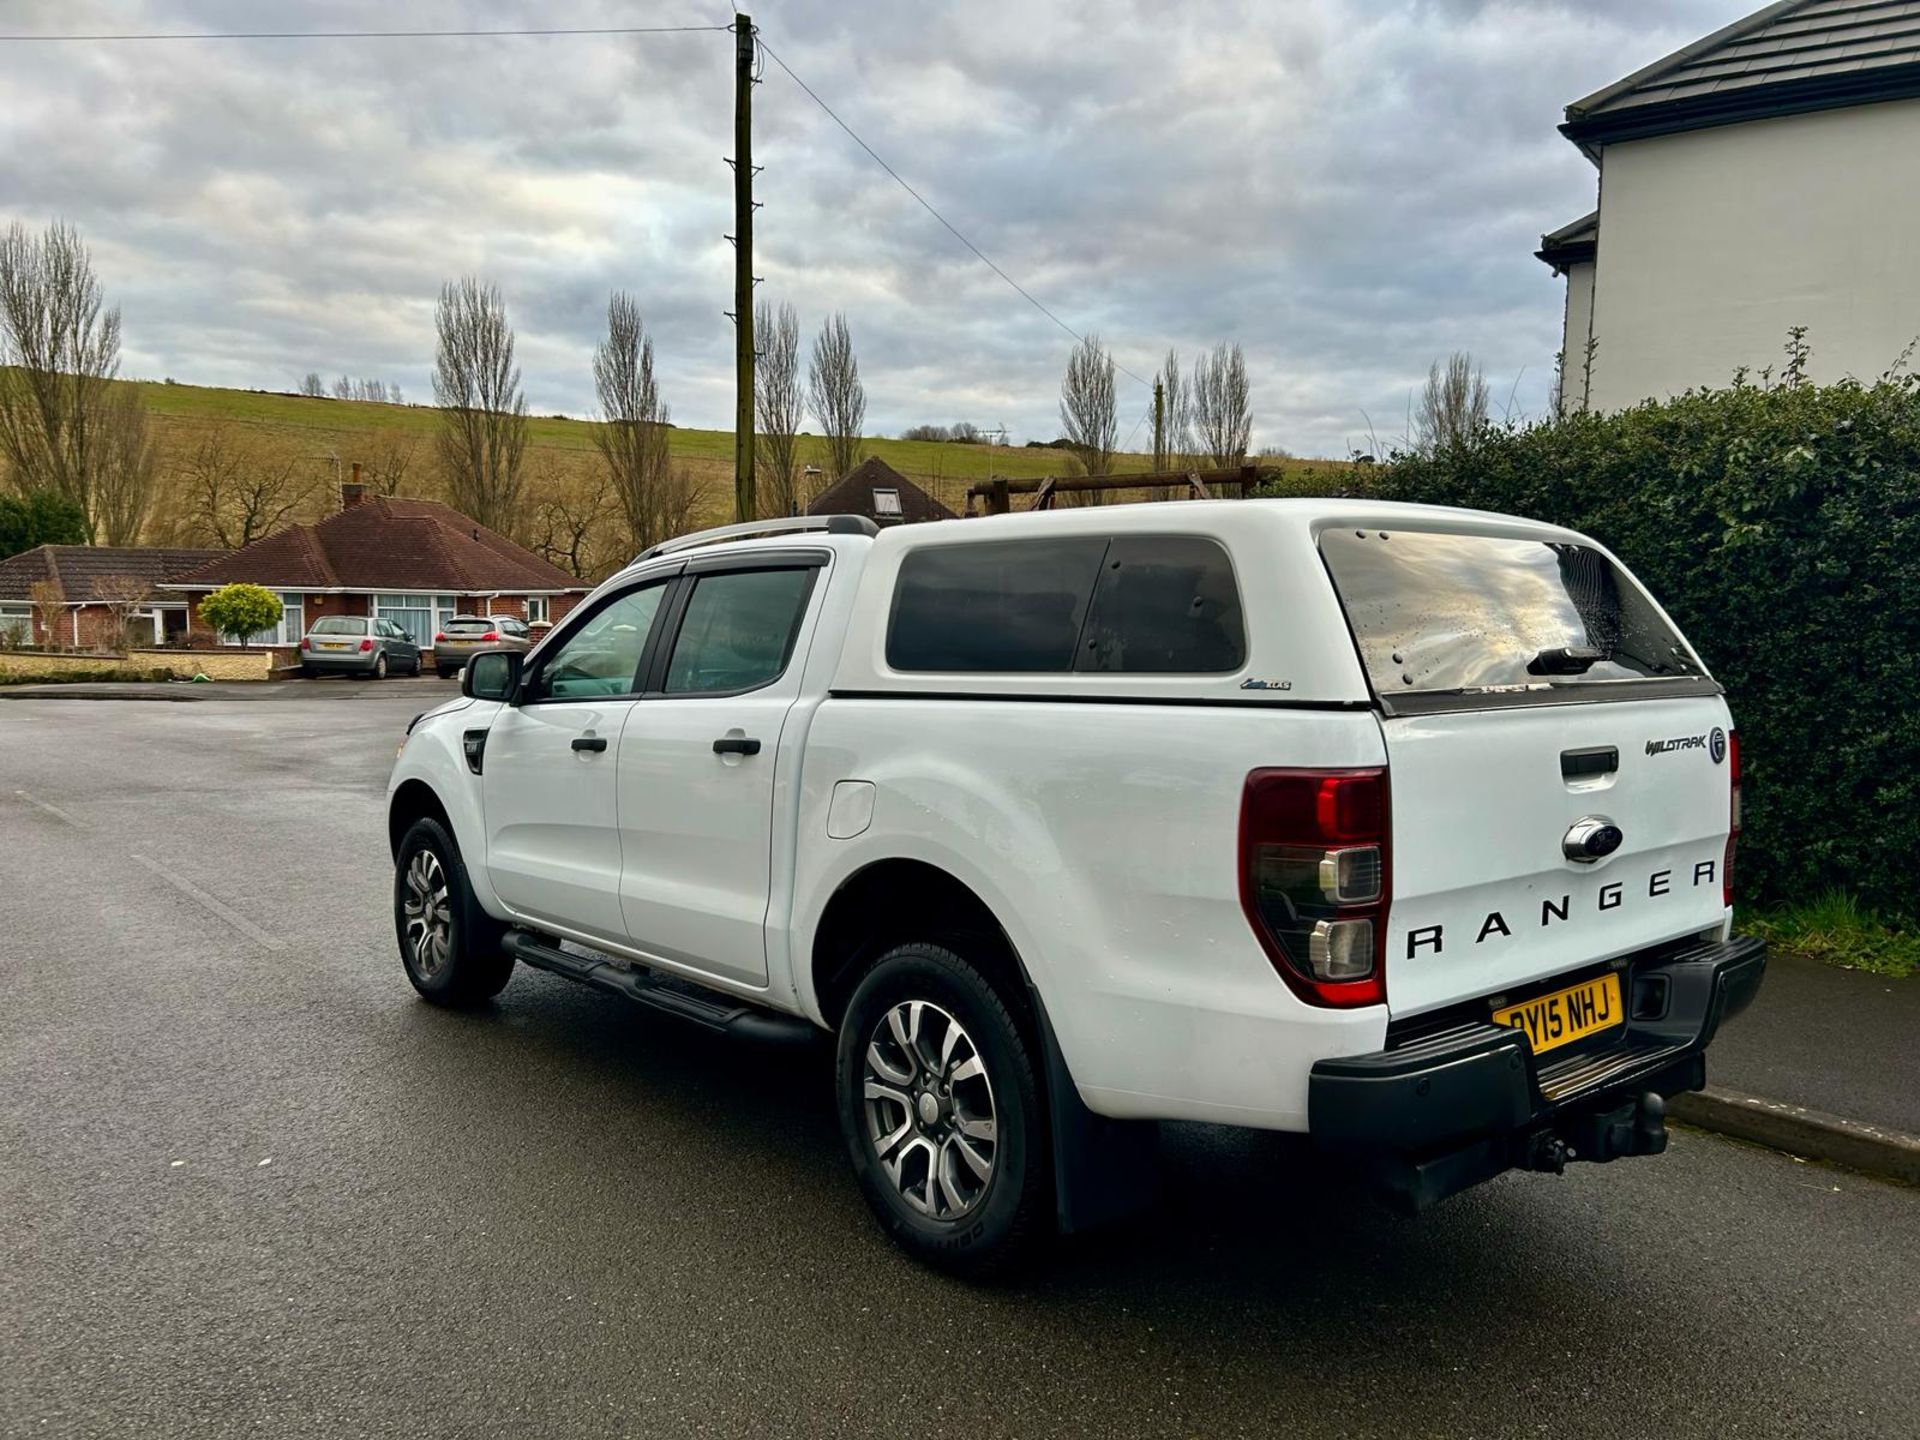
left=0, top=695, right=1920, bottom=1440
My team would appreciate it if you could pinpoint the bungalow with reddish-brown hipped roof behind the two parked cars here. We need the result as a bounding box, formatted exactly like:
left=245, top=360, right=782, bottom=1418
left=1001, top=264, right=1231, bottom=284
left=159, top=484, right=591, bottom=666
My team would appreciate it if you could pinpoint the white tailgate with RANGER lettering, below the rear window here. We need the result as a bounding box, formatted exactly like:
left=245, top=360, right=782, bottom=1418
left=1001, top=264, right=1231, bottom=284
left=1382, top=697, right=1732, bottom=1016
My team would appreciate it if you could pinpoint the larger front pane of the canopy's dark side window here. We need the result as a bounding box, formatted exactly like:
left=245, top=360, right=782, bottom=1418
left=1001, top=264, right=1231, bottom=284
left=887, top=536, right=1106, bottom=674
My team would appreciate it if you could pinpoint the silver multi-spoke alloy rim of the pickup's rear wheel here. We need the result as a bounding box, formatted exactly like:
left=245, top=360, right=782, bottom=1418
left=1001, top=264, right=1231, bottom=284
left=860, top=1000, right=998, bottom=1219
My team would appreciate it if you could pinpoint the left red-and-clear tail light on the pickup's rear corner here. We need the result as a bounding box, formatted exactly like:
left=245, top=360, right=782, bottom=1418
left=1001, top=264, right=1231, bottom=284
left=1240, top=770, right=1392, bottom=1006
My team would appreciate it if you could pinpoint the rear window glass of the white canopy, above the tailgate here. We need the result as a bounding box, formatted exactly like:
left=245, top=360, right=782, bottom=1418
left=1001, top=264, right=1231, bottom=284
left=1321, top=530, right=1703, bottom=697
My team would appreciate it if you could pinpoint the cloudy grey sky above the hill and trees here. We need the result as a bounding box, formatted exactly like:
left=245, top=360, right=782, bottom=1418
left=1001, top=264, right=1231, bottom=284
left=0, top=0, right=1759, bottom=455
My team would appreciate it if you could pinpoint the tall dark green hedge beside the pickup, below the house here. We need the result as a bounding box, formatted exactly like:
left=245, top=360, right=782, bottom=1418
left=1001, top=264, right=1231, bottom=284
left=1336, top=378, right=1920, bottom=920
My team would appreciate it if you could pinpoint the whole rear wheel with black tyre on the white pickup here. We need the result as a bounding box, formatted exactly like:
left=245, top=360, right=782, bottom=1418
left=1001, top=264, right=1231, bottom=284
left=835, top=943, right=1052, bottom=1279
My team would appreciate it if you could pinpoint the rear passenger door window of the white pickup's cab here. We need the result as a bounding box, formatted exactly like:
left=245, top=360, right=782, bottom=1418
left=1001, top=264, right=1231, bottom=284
left=666, top=570, right=814, bottom=695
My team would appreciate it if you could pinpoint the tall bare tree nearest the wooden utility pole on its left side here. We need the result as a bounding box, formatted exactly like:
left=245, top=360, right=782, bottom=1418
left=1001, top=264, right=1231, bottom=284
left=593, top=290, right=685, bottom=551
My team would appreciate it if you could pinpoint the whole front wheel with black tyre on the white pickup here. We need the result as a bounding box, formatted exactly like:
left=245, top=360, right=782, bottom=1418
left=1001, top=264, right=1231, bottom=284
left=394, top=820, right=513, bottom=1006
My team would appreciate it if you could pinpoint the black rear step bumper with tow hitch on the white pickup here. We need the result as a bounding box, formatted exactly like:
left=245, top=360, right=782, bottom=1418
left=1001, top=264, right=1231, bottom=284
left=1308, top=937, right=1766, bottom=1212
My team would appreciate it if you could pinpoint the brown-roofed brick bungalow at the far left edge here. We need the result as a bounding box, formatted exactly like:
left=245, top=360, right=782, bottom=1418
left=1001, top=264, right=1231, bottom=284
left=0, top=545, right=227, bottom=649
